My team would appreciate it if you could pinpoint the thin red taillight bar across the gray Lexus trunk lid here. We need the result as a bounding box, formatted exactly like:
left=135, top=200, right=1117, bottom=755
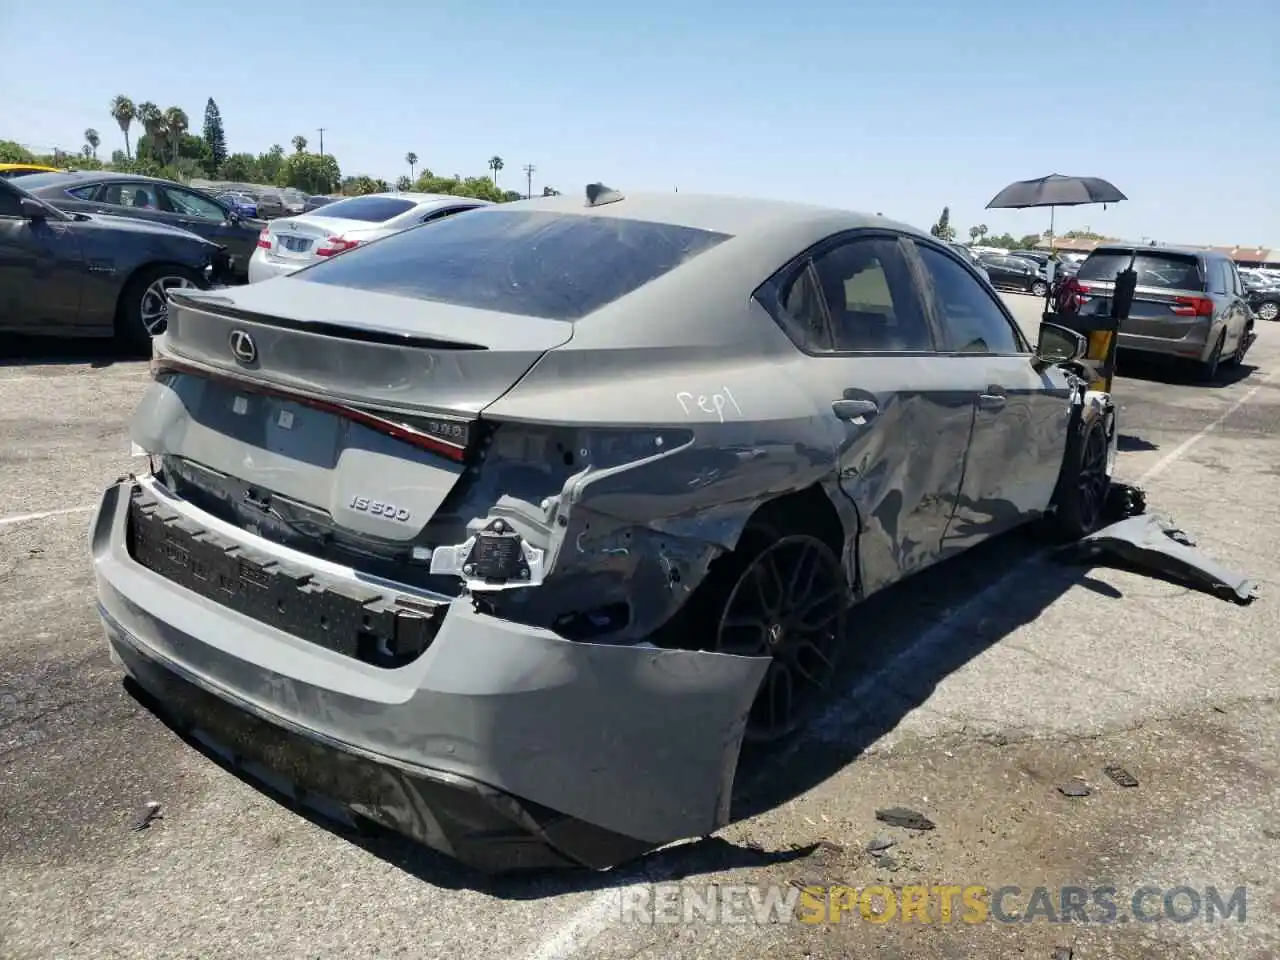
left=151, top=344, right=477, bottom=463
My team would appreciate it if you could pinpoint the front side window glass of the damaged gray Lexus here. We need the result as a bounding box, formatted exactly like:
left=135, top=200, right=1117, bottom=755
left=916, top=243, right=1028, bottom=353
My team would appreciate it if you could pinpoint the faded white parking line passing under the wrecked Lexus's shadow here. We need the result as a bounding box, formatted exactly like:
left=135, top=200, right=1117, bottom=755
left=526, top=376, right=1270, bottom=960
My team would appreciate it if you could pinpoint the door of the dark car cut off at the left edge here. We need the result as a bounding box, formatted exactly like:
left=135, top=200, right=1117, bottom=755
left=0, top=182, right=84, bottom=333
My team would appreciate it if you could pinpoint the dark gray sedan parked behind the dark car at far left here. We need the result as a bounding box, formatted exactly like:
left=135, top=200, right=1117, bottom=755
left=22, top=170, right=266, bottom=282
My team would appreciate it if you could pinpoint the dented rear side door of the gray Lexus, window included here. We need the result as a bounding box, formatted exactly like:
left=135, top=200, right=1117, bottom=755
left=762, top=232, right=973, bottom=594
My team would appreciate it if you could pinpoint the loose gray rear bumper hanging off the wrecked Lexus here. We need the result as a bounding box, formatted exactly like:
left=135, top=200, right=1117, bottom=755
left=90, top=477, right=767, bottom=872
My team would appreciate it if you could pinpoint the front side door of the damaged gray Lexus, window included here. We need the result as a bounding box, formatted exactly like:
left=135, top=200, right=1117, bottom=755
left=915, top=239, right=1071, bottom=547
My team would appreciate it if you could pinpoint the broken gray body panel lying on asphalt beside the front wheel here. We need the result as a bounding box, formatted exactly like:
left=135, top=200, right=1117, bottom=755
left=1068, top=513, right=1261, bottom=604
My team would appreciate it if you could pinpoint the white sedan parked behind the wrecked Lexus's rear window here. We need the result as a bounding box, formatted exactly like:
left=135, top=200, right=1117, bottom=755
left=248, top=193, right=489, bottom=283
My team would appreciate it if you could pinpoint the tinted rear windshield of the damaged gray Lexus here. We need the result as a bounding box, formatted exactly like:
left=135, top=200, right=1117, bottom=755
left=294, top=205, right=728, bottom=320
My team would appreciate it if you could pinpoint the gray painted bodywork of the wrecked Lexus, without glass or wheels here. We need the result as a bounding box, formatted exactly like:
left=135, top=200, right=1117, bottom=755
left=93, top=195, right=1114, bottom=870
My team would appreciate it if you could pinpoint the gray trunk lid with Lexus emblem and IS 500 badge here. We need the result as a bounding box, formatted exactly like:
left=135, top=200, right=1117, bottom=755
left=132, top=279, right=572, bottom=562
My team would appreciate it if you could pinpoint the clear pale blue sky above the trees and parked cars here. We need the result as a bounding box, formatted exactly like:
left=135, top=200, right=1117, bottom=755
left=0, top=0, right=1280, bottom=247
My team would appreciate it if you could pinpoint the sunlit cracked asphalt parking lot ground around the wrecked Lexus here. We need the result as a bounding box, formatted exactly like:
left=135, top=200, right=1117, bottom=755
left=0, top=296, right=1280, bottom=960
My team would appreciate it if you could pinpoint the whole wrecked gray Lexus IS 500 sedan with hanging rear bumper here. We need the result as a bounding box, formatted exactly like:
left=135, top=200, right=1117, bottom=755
left=90, top=184, right=1116, bottom=872
